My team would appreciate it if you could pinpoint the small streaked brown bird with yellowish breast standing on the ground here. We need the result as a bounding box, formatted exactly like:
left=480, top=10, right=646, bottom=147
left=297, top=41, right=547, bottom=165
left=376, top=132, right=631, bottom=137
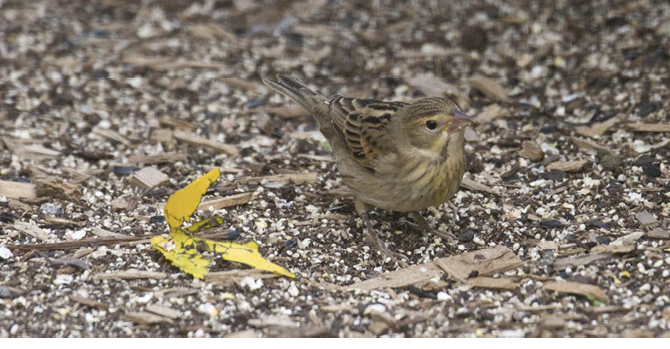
left=263, top=75, right=473, bottom=258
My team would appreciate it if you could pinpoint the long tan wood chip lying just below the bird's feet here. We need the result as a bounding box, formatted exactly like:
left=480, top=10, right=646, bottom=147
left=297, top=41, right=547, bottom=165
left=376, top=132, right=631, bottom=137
left=347, top=246, right=523, bottom=291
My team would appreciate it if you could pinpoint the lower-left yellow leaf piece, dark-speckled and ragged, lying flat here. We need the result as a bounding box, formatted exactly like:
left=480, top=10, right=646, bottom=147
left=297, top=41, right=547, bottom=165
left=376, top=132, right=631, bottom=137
left=151, top=229, right=210, bottom=279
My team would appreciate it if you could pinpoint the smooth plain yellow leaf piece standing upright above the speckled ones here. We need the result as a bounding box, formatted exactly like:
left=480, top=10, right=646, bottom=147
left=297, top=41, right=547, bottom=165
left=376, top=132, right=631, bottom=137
left=163, top=168, right=221, bottom=230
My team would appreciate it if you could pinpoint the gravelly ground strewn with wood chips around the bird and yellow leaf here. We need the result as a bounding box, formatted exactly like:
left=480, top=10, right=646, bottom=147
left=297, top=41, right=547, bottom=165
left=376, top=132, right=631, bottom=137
left=0, top=0, right=670, bottom=337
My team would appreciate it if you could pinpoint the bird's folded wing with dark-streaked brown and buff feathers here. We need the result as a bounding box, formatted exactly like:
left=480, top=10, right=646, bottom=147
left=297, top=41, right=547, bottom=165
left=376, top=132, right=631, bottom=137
left=329, top=96, right=407, bottom=171
